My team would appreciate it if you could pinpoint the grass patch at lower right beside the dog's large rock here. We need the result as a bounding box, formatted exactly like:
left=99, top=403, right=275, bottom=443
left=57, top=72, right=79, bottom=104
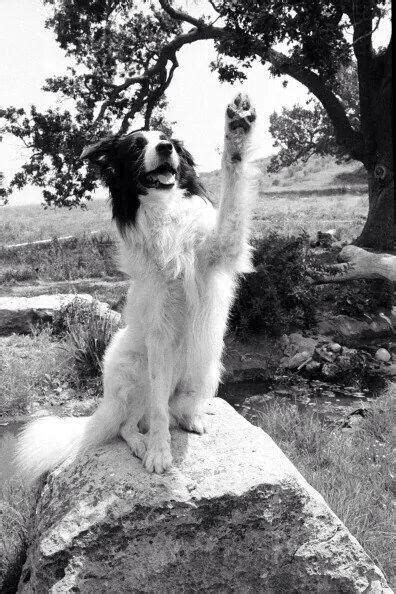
left=259, top=387, right=395, bottom=580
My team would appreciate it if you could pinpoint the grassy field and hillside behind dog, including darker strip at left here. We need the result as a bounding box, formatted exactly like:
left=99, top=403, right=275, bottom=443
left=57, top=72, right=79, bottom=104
left=0, top=159, right=368, bottom=293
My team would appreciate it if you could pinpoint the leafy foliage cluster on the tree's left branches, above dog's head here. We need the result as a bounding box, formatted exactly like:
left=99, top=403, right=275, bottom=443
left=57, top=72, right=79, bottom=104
left=0, top=0, right=181, bottom=207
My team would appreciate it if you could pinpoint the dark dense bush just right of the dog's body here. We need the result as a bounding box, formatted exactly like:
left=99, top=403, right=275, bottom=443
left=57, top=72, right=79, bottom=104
left=230, top=233, right=317, bottom=338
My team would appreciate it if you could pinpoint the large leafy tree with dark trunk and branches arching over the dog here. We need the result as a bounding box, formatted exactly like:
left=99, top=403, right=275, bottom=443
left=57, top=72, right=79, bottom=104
left=2, top=0, right=393, bottom=250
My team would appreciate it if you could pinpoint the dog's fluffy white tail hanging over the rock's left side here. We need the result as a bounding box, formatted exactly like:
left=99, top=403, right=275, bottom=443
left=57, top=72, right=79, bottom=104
left=15, top=401, right=123, bottom=483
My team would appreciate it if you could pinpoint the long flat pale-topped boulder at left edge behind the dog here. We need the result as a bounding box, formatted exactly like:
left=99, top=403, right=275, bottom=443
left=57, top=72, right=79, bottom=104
left=0, top=293, right=120, bottom=336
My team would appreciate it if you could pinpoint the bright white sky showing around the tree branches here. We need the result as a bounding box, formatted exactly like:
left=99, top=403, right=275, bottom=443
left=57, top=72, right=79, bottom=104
left=0, top=0, right=387, bottom=202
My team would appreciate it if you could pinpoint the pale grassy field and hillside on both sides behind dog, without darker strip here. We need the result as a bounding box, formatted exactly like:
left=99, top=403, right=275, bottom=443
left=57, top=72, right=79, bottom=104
left=0, top=157, right=368, bottom=245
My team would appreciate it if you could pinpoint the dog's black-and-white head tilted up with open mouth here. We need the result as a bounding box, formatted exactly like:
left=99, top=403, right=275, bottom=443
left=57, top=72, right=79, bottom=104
left=81, top=131, right=205, bottom=233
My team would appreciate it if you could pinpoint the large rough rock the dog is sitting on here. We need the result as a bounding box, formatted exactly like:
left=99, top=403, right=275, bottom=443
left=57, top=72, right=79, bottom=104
left=18, top=399, right=391, bottom=594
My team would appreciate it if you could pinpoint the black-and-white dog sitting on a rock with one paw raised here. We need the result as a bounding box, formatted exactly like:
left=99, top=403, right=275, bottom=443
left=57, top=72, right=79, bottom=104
left=17, top=94, right=256, bottom=480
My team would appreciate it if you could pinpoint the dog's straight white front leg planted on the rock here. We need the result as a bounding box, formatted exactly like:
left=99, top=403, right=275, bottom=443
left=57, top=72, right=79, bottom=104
left=143, top=332, right=173, bottom=473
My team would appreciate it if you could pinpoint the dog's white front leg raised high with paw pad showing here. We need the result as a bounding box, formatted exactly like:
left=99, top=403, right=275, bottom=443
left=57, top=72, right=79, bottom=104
left=209, top=94, right=256, bottom=272
